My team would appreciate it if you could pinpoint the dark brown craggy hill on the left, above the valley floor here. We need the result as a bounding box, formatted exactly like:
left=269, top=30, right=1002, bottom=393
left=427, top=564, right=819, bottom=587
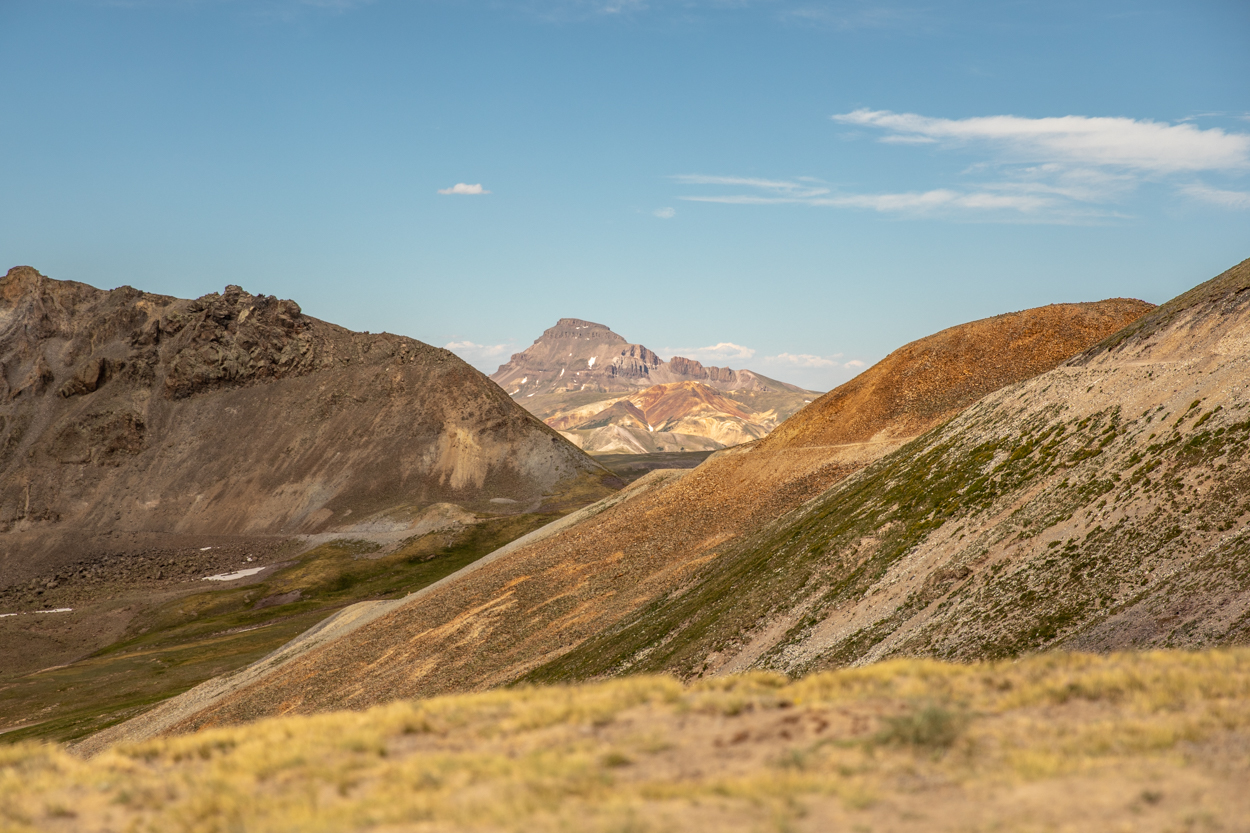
left=0, top=266, right=608, bottom=584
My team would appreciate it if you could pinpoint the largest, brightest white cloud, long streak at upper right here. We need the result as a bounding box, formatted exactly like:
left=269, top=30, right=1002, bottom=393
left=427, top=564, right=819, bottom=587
left=833, top=109, right=1250, bottom=174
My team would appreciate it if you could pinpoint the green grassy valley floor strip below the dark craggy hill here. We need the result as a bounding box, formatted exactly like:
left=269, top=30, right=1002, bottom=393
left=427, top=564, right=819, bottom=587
left=0, top=514, right=559, bottom=743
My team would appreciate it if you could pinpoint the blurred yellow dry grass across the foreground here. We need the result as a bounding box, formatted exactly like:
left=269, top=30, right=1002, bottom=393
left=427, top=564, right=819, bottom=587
left=0, top=649, right=1250, bottom=833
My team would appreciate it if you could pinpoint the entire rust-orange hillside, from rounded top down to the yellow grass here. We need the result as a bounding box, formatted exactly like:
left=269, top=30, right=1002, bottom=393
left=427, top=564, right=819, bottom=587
left=90, top=300, right=1151, bottom=745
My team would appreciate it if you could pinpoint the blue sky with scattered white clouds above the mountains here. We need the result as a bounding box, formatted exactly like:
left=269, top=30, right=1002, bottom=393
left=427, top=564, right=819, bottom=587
left=0, top=0, right=1250, bottom=389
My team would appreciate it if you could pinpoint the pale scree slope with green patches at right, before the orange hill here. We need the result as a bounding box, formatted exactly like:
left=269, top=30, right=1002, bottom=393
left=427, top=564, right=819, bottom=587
left=535, top=260, right=1250, bottom=678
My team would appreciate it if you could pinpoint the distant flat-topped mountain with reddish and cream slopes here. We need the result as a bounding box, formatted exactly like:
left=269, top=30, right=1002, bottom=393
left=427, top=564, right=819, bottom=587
left=490, top=318, right=819, bottom=454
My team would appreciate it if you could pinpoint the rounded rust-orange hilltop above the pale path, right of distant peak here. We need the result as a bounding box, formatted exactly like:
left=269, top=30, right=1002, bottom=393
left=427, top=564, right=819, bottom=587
left=761, top=298, right=1154, bottom=448
